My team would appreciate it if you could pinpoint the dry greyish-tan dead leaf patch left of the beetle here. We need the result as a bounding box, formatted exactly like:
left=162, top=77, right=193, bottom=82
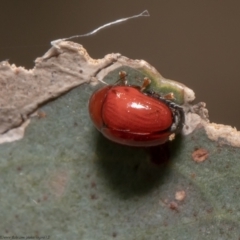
left=0, top=41, right=120, bottom=142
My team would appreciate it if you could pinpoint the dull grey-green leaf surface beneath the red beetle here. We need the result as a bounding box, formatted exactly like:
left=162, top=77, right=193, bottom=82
left=0, top=82, right=240, bottom=240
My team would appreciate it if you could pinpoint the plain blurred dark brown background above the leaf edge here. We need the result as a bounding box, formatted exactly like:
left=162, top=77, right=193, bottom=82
left=0, top=0, right=240, bottom=129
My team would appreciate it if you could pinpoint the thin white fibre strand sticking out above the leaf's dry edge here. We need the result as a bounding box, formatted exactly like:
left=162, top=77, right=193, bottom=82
left=51, top=10, right=150, bottom=47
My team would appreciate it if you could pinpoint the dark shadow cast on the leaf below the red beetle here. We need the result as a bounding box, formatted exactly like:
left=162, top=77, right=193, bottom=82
left=96, top=130, right=184, bottom=199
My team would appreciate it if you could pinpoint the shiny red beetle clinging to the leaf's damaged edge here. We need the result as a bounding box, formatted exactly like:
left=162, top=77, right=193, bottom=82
left=89, top=71, right=184, bottom=147
